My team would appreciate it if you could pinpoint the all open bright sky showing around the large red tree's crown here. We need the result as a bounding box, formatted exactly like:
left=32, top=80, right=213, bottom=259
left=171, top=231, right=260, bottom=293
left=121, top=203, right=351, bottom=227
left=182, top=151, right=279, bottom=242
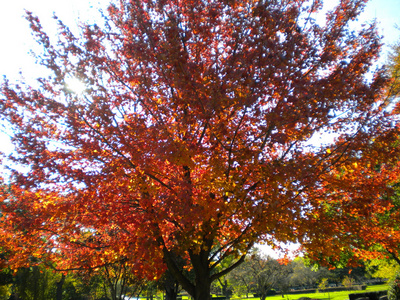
left=0, top=0, right=400, bottom=256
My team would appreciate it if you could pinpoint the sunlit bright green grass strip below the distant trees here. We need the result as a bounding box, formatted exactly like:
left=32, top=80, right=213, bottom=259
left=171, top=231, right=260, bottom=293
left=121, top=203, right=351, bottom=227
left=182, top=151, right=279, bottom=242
left=231, top=284, right=388, bottom=300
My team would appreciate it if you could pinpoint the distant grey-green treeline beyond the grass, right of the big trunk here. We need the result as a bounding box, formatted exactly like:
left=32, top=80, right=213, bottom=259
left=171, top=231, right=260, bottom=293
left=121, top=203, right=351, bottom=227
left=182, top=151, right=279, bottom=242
left=213, top=253, right=385, bottom=299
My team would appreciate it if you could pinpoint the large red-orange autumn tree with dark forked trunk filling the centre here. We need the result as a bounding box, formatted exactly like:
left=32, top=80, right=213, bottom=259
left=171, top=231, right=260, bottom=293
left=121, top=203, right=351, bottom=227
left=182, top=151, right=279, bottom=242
left=0, top=0, right=398, bottom=300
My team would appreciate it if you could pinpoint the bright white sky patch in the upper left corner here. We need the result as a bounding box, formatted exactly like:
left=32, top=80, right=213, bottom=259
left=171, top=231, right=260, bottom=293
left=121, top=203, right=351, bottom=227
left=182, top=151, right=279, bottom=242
left=0, top=0, right=107, bottom=82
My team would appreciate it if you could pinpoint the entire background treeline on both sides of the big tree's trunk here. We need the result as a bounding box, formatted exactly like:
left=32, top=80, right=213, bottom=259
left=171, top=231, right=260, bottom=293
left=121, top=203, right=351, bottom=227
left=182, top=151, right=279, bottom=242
left=0, top=252, right=390, bottom=300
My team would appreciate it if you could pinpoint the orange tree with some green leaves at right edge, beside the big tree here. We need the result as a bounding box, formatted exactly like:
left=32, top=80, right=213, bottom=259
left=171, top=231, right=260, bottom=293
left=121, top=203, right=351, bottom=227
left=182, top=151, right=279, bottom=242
left=303, top=34, right=400, bottom=267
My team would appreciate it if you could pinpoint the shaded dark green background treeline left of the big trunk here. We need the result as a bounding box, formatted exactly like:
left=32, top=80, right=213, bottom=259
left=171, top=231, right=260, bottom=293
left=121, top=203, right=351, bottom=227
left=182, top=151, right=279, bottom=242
left=0, top=262, right=158, bottom=300
